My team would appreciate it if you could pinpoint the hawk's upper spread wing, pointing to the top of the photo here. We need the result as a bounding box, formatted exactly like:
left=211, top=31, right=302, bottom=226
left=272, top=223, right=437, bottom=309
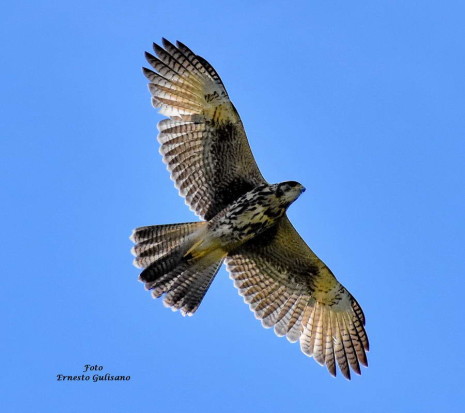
left=144, top=39, right=266, bottom=220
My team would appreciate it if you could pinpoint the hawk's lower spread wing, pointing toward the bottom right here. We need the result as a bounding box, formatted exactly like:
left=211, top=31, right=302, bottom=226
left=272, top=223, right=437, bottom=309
left=226, top=216, right=368, bottom=379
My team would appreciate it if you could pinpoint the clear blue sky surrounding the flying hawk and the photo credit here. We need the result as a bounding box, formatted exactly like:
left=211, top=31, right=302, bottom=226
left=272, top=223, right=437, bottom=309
left=0, top=0, right=465, bottom=412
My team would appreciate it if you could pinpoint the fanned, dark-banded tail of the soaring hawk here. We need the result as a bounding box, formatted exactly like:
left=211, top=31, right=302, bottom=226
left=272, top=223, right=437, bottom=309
left=131, top=222, right=226, bottom=315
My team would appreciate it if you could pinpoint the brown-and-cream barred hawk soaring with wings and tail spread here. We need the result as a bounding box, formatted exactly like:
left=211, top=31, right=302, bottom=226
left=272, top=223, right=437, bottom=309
left=131, top=39, right=368, bottom=379
